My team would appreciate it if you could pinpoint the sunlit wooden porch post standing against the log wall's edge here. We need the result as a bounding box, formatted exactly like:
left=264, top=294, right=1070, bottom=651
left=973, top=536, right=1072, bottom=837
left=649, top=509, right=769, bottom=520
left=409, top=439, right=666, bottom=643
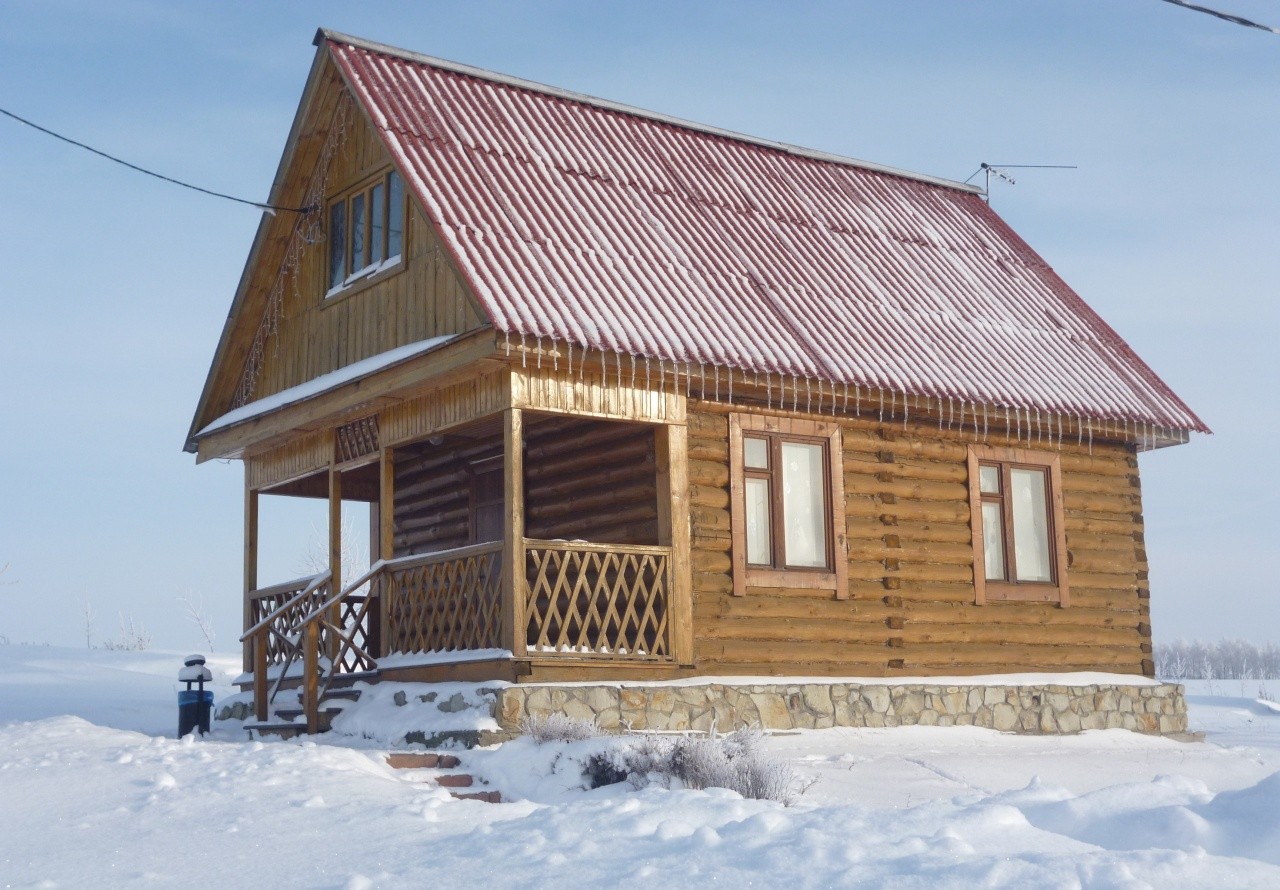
left=657, top=424, right=694, bottom=665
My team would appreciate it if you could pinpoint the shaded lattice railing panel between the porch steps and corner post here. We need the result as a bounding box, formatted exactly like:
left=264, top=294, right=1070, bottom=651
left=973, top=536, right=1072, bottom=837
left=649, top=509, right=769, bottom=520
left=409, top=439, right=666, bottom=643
left=381, top=543, right=504, bottom=652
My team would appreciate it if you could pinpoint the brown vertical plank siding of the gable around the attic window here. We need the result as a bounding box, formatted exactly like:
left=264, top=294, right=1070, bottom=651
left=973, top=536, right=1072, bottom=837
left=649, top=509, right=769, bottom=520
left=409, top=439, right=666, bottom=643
left=236, top=76, right=488, bottom=409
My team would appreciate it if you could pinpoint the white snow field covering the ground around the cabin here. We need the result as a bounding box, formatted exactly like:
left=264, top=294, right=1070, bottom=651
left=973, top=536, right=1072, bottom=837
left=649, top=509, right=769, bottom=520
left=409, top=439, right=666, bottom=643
left=0, top=645, right=1280, bottom=890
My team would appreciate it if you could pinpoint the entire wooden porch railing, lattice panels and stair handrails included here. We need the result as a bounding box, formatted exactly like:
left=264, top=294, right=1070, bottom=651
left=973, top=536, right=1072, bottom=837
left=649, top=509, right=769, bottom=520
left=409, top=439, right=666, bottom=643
left=241, top=539, right=673, bottom=732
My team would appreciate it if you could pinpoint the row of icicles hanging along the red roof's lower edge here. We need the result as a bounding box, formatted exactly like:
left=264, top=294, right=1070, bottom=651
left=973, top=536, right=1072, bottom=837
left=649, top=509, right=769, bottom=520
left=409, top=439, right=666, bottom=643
left=503, top=333, right=1187, bottom=453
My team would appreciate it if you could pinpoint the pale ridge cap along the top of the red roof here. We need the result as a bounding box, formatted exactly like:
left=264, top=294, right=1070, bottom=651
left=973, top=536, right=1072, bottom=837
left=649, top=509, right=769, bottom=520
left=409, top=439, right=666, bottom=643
left=312, top=28, right=982, bottom=195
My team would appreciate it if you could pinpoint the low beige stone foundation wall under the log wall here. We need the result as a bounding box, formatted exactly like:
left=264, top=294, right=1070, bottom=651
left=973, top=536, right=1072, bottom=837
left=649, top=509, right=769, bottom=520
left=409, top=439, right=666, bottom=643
left=494, top=683, right=1187, bottom=735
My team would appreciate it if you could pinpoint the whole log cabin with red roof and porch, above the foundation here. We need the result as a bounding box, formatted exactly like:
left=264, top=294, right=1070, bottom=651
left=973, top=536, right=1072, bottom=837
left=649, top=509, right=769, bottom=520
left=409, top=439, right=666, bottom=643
left=186, top=31, right=1207, bottom=727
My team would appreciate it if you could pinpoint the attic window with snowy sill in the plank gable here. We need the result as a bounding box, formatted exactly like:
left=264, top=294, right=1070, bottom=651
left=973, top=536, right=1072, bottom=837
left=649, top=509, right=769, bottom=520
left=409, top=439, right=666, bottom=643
left=325, top=170, right=404, bottom=296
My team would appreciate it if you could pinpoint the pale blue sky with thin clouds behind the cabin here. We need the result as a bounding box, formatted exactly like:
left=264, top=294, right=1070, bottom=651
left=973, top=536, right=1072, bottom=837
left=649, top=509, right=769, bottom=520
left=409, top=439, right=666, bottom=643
left=0, top=0, right=1280, bottom=651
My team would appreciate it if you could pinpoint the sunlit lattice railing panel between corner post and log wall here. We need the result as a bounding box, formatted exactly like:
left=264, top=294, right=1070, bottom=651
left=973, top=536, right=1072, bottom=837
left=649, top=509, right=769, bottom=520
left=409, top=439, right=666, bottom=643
left=525, top=542, right=671, bottom=661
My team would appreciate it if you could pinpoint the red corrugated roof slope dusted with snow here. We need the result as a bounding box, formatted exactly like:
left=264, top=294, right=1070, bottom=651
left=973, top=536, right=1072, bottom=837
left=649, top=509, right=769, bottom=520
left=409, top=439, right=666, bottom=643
left=326, top=35, right=1207, bottom=432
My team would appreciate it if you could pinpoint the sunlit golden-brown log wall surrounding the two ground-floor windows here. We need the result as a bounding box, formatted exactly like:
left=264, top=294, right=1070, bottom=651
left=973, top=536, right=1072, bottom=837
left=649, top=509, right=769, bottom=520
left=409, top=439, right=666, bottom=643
left=689, top=400, right=1151, bottom=676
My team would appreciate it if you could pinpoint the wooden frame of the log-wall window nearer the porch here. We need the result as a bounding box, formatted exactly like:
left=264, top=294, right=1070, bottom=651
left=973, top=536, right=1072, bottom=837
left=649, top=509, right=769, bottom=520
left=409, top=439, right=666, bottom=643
left=728, top=414, right=849, bottom=599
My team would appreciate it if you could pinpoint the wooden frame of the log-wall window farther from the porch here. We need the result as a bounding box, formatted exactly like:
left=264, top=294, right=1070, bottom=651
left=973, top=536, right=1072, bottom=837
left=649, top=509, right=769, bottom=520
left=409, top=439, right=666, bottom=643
left=968, top=444, right=1070, bottom=607
